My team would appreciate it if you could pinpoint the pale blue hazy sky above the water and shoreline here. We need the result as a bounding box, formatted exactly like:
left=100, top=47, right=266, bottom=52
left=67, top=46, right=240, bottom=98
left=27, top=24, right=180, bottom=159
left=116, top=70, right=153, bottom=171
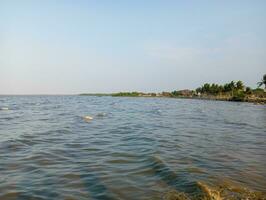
left=0, top=0, right=266, bottom=94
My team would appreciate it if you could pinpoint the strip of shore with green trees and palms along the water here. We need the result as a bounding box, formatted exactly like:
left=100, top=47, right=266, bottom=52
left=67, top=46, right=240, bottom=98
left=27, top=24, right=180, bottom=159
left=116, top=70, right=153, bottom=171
left=81, top=74, right=266, bottom=104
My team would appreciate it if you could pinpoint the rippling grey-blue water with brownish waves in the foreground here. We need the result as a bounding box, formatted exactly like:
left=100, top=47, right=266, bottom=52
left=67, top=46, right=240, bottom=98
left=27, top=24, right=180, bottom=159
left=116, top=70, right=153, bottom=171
left=0, top=96, right=266, bottom=200
